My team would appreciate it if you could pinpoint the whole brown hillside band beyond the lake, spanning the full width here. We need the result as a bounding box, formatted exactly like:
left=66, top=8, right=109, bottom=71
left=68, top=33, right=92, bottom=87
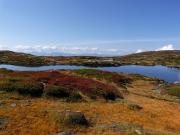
left=0, top=50, right=180, bottom=67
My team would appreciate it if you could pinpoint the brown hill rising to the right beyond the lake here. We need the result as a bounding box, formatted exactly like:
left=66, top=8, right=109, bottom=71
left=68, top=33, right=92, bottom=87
left=115, top=50, right=180, bottom=67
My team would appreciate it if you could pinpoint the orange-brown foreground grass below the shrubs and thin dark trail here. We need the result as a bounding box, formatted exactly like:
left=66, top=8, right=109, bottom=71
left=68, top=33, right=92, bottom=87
left=0, top=93, right=180, bottom=135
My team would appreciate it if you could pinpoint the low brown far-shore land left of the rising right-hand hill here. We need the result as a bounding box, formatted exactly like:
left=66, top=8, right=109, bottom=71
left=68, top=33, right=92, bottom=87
left=0, top=51, right=121, bottom=66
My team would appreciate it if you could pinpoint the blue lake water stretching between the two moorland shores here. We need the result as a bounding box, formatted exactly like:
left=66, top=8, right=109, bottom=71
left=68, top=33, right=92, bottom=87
left=0, top=64, right=180, bottom=83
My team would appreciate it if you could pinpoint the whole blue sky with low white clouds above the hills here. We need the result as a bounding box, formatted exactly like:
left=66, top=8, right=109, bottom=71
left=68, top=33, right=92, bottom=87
left=0, top=0, right=180, bottom=55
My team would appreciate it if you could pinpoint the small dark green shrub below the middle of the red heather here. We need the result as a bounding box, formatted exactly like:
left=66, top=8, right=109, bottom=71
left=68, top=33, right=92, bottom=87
left=44, top=85, right=70, bottom=98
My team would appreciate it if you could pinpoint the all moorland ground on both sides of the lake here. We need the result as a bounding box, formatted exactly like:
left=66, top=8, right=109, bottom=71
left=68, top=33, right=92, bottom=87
left=0, top=51, right=180, bottom=135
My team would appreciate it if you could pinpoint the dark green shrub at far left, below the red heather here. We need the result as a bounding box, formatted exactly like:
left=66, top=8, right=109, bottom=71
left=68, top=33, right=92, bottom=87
left=15, top=82, right=43, bottom=97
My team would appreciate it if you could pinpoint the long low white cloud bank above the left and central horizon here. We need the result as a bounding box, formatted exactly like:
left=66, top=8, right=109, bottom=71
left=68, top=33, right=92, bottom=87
left=0, top=45, right=121, bottom=55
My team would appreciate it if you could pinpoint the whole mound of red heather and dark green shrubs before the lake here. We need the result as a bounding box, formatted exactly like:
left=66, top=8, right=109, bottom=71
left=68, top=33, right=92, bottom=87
left=0, top=71, right=123, bottom=101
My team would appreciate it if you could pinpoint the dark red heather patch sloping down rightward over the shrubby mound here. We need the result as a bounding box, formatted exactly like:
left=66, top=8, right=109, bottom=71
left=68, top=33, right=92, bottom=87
left=31, top=71, right=122, bottom=98
